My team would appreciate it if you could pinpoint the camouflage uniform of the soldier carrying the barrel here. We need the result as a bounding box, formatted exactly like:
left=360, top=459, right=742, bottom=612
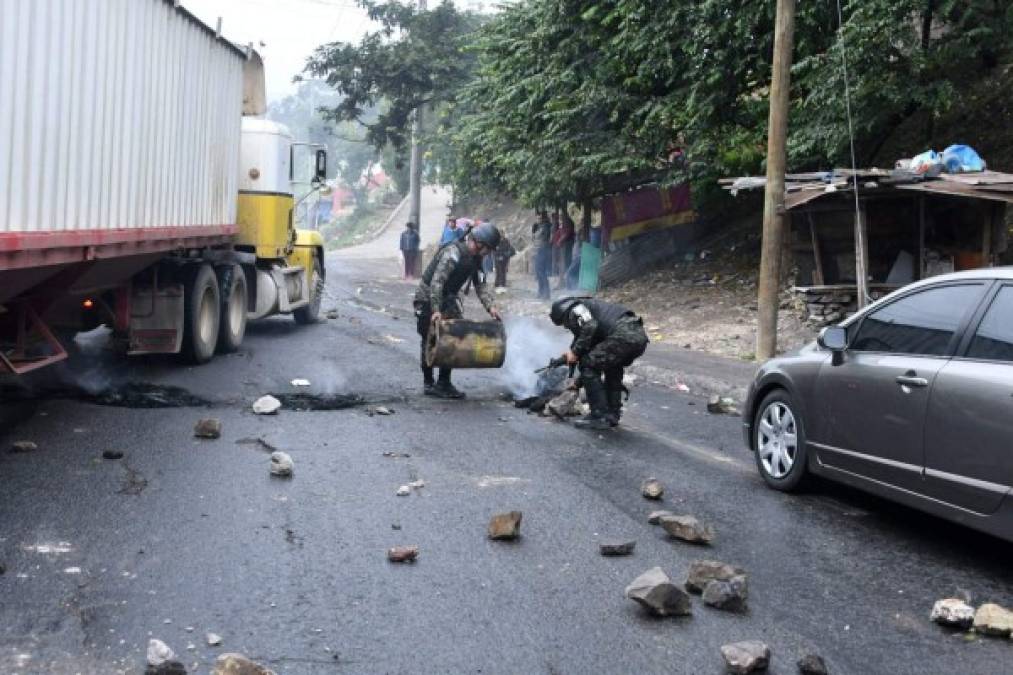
left=414, top=239, right=493, bottom=385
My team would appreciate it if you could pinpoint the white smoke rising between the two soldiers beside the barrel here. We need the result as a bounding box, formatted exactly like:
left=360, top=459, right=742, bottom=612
left=499, top=316, right=572, bottom=398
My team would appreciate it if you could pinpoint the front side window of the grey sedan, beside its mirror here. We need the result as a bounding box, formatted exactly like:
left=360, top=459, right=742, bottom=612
left=850, top=284, right=981, bottom=356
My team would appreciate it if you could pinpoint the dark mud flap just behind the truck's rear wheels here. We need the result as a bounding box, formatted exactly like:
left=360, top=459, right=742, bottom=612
left=128, top=284, right=183, bottom=356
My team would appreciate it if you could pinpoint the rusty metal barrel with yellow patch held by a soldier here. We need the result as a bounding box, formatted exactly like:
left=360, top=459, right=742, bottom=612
left=425, top=319, right=507, bottom=368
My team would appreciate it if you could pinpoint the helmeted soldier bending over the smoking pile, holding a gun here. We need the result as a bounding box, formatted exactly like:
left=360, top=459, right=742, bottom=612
left=549, top=298, right=648, bottom=430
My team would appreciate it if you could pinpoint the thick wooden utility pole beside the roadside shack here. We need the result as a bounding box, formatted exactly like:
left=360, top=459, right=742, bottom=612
left=757, top=0, right=795, bottom=361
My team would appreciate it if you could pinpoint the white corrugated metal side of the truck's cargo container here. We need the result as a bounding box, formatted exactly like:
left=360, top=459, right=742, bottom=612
left=0, top=0, right=243, bottom=232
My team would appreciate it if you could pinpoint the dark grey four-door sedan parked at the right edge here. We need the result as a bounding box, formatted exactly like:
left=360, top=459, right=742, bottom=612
left=743, top=268, right=1013, bottom=540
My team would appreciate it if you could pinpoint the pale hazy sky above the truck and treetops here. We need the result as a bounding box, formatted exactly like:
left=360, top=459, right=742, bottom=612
left=180, top=0, right=489, bottom=99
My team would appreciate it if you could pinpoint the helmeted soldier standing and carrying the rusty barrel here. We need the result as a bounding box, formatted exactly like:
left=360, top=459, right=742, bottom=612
left=414, top=223, right=502, bottom=398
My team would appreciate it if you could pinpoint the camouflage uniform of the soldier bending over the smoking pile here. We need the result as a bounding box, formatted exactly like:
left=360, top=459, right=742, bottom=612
left=563, top=298, right=649, bottom=425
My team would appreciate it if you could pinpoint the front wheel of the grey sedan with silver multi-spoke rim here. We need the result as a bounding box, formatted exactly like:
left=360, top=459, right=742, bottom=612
left=753, top=389, right=807, bottom=492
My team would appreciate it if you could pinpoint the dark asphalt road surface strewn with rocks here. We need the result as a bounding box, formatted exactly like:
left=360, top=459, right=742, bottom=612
left=0, top=222, right=1013, bottom=675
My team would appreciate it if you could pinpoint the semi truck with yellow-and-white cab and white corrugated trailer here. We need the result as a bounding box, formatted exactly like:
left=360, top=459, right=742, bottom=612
left=0, top=0, right=327, bottom=374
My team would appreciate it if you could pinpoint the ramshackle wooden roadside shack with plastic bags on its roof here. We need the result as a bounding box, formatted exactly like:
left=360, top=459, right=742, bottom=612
left=720, top=168, right=1013, bottom=323
